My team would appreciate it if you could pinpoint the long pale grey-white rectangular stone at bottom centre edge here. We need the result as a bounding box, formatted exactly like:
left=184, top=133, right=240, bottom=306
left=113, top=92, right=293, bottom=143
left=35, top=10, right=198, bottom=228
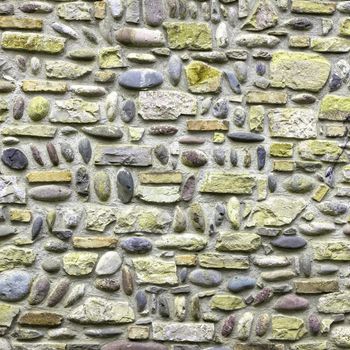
left=152, top=321, right=214, bottom=343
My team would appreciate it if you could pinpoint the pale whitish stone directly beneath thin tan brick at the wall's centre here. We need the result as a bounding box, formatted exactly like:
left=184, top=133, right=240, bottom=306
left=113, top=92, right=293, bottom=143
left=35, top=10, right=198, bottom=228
left=137, top=185, right=181, bottom=203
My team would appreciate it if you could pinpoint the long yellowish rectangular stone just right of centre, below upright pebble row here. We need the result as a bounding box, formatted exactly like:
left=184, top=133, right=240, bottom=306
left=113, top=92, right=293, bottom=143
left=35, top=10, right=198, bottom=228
left=199, top=171, right=256, bottom=194
